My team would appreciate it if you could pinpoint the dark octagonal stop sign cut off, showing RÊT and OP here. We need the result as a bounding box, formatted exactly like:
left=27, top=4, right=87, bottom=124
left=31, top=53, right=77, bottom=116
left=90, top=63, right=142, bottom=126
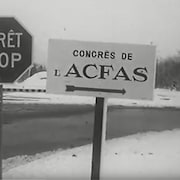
left=0, top=17, right=32, bottom=83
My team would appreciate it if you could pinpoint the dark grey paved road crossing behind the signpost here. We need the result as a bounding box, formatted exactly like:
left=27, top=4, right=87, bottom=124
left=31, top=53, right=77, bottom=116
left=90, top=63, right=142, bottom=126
left=3, top=104, right=180, bottom=159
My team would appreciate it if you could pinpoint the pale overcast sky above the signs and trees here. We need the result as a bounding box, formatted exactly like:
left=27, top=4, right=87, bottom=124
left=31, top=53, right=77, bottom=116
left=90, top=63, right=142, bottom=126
left=0, top=0, right=180, bottom=64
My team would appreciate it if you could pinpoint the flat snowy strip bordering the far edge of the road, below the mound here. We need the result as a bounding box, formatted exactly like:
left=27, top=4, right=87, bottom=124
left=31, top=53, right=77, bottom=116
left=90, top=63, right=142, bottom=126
left=3, top=89, right=180, bottom=108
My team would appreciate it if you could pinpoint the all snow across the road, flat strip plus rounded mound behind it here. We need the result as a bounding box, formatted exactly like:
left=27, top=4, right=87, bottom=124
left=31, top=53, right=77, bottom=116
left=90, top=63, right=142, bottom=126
left=4, top=71, right=180, bottom=108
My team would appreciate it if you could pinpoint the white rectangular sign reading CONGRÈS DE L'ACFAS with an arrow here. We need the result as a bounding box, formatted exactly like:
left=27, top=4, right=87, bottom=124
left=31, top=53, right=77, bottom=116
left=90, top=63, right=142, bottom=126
left=47, top=39, right=155, bottom=99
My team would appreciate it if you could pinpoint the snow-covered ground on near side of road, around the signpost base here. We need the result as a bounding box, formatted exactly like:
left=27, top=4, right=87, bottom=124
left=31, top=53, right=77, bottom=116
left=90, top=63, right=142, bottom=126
left=3, top=129, right=180, bottom=180
